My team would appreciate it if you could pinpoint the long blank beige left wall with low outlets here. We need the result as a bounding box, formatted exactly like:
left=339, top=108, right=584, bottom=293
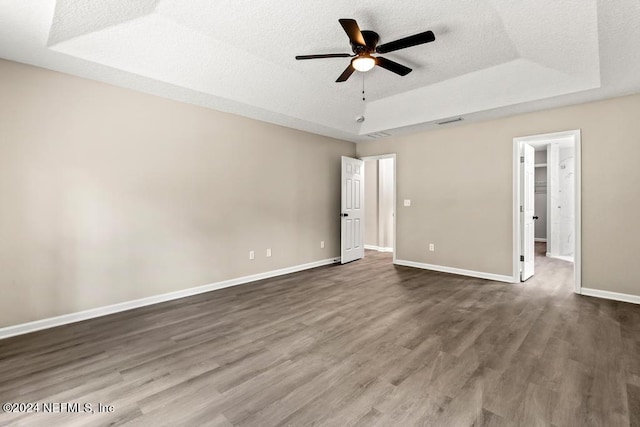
left=0, top=60, right=355, bottom=327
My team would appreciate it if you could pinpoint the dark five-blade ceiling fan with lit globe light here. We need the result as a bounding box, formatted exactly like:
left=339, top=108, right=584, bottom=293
left=296, top=19, right=436, bottom=83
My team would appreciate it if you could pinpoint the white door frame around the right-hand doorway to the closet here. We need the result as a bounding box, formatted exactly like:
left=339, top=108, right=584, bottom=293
left=512, top=129, right=582, bottom=294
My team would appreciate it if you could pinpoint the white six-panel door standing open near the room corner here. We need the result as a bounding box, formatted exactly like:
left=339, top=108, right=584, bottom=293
left=340, top=156, right=364, bottom=264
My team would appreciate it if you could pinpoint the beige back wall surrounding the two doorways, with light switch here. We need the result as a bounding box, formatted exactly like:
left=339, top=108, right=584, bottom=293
left=357, top=95, right=640, bottom=295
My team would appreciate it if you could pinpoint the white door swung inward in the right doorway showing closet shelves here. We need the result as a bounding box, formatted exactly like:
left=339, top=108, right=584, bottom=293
left=520, top=143, right=535, bottom=282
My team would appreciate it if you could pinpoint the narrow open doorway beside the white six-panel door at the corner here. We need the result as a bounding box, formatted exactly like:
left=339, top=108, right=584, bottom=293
left=361, top=154, right=396, bottom=262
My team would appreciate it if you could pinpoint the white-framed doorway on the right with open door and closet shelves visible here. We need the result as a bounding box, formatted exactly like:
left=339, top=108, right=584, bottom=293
left=513, top=130, right=581, bottom=294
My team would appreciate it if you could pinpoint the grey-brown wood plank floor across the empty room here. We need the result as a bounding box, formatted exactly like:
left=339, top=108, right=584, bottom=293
left=0, top=244, right=640, bottom=426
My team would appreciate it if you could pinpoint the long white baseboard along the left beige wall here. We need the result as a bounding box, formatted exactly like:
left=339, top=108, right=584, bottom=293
left=0, top=258, right=340, bottom=339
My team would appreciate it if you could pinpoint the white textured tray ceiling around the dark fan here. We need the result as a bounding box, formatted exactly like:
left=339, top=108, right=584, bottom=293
left=0, top=0, right=640, bottom=142
